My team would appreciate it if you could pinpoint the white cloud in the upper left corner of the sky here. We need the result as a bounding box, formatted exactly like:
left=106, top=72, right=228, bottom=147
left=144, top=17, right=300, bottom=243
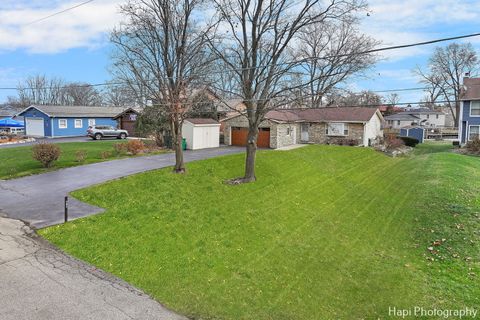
left=0, top=0, right=120, bottom=53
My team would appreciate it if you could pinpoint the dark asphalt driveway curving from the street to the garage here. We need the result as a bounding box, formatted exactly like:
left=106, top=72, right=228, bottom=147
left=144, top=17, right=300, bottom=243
left=0, top=147, right=245, bottom=228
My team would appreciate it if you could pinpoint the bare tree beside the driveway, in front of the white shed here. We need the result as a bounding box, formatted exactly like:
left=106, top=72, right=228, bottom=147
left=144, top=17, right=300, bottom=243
left=111, top=0, right=210, bottom=173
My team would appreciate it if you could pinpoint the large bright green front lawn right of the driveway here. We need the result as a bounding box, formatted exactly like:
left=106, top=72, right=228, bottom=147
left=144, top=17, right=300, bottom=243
left=40, top=145, right=480, bottom=319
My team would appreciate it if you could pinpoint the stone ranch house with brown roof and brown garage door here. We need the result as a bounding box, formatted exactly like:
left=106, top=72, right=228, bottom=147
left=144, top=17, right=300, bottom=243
left=222, top=107, right=383, bottom=149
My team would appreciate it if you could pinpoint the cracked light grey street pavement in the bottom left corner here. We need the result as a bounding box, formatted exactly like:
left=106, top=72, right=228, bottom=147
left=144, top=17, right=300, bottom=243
left=0, top=218, right=183, bottom=320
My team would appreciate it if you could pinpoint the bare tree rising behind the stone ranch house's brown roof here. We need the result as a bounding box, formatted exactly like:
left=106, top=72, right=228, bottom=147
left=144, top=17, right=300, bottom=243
left=294, top=17, right=380, bottom=108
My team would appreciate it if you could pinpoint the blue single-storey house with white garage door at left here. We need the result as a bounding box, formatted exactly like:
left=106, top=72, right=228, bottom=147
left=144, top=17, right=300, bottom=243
left=18, top=105, right=127, bottom=138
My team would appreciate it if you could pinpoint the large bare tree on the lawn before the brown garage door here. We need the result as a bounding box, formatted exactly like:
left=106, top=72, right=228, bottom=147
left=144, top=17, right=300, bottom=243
left=210, top=0, right=364, bottom=183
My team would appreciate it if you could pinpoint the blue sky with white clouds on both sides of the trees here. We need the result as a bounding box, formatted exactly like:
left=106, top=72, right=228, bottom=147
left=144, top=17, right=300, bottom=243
left=0, top=0, right=480, bottom=102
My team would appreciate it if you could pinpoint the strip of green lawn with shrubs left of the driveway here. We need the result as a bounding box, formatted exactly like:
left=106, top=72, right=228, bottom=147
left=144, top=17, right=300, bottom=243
left=0, top=140, right=161, bottom=179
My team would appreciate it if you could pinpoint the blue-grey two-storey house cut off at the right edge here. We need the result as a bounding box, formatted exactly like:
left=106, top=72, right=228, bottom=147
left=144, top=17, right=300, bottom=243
left=458, top=78, right=480, bottom=145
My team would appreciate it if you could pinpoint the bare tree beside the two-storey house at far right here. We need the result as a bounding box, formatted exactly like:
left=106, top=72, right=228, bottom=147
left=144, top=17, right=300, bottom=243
left=414, top=43, right=478, bottom=127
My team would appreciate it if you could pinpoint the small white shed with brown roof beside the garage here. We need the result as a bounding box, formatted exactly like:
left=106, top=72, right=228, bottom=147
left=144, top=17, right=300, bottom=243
left=182, top=118, right=220, bottom=150
